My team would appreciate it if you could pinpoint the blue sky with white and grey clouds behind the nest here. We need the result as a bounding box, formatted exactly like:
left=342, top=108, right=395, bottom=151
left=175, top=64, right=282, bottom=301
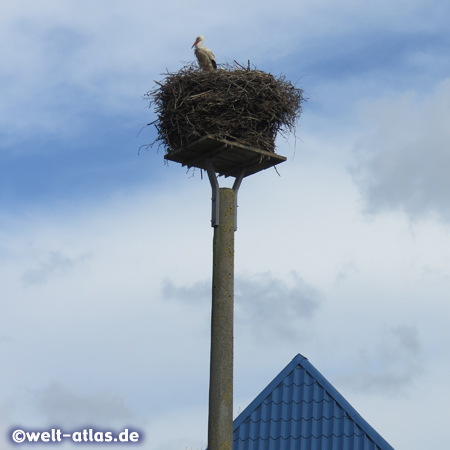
left=0, top=0, right=450, bottom=450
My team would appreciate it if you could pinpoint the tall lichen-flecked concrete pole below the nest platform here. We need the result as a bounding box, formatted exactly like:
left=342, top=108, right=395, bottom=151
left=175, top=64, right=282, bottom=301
left=208, top=188, right=236, bottom=450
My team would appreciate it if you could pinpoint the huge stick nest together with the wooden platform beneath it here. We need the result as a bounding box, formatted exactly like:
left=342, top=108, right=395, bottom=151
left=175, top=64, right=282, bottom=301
left=144, top=63, right=305, bottom=165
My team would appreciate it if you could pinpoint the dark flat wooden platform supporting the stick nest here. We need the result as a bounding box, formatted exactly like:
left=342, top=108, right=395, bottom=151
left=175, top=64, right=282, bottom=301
left=164, top=135, right=286, bottom=177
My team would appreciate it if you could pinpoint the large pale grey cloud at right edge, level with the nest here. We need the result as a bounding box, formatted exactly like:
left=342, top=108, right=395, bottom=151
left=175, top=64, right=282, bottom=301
left=354, top=79, right=450, bottom=221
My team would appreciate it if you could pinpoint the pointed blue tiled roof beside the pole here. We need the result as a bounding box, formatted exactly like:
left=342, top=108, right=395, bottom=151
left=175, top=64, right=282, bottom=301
left=233, top=355, right=394, bottom=450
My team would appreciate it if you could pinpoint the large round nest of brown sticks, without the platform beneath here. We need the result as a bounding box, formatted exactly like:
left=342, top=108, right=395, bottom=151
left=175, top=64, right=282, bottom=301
left=145, top=63, right=305, bottom=152
